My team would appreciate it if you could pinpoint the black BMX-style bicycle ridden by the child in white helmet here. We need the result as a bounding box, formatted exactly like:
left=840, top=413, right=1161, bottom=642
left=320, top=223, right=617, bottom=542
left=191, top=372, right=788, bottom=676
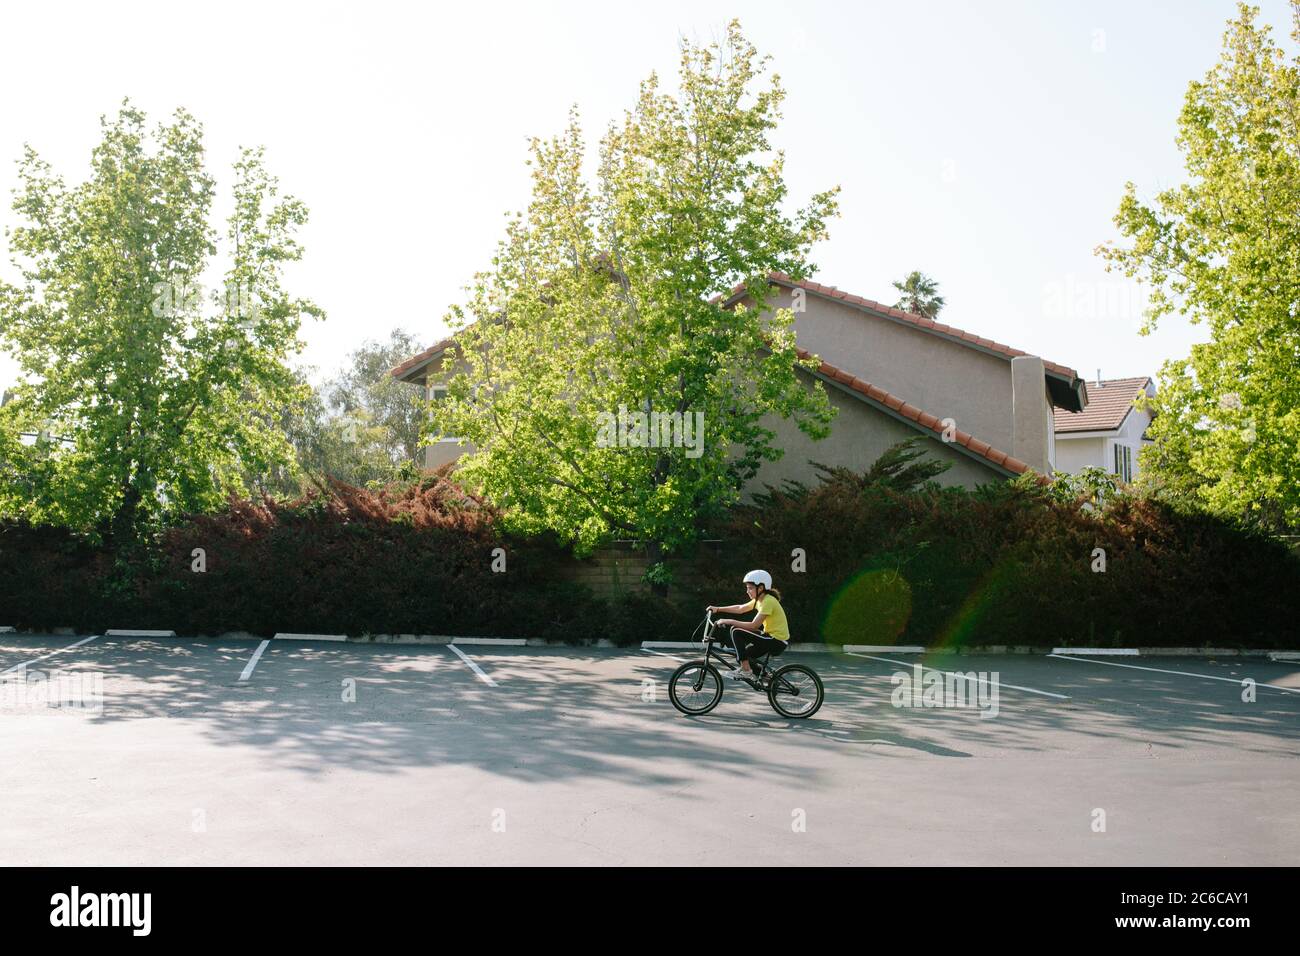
left=668, top=611, right=826, bottom=719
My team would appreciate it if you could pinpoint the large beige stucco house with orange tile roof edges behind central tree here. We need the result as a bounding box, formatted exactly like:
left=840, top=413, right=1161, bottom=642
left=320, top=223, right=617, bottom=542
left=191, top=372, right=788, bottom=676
left=391, top=273, right=1088, bottom=492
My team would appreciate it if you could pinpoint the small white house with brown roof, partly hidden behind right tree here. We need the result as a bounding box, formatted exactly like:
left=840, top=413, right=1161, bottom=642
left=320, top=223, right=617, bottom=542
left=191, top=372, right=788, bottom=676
left=1054, top=373, right=1156, bottom=481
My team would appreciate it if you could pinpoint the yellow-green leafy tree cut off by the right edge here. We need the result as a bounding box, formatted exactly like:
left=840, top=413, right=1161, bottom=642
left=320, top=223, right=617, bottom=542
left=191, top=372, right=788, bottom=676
left=1097, top=0, right=1300, bottom=529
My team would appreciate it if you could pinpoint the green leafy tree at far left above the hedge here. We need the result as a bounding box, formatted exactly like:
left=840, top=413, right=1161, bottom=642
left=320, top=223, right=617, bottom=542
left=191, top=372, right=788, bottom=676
left=0, top=103, right=321, bottom=540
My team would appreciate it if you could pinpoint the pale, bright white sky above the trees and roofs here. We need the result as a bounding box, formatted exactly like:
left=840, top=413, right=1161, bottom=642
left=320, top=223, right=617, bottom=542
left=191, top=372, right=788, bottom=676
left=0, top=0, right=1294, bottom=388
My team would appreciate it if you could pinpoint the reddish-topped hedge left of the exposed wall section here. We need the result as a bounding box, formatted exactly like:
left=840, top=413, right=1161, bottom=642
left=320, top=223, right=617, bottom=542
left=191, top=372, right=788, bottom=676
left=0, top=479, right=613, bottom=639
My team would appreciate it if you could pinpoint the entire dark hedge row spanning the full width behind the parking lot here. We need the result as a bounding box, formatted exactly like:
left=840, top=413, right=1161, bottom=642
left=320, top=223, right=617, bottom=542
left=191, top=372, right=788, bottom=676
left=0, top=472, right=1300, bottom=648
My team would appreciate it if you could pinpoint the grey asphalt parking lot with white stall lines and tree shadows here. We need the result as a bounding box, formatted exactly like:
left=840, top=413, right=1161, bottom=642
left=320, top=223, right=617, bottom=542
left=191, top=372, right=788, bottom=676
left=0, top=633, right=1300, bottom=865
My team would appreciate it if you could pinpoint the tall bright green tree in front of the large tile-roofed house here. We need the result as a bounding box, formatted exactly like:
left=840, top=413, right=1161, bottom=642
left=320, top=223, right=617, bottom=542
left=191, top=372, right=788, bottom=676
left=433, top=22, right=836, bottom=553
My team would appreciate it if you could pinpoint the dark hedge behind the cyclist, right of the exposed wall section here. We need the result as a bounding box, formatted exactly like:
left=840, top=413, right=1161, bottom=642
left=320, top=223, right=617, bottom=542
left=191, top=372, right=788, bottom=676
left=690, top=472, right=1300, bottom=648
